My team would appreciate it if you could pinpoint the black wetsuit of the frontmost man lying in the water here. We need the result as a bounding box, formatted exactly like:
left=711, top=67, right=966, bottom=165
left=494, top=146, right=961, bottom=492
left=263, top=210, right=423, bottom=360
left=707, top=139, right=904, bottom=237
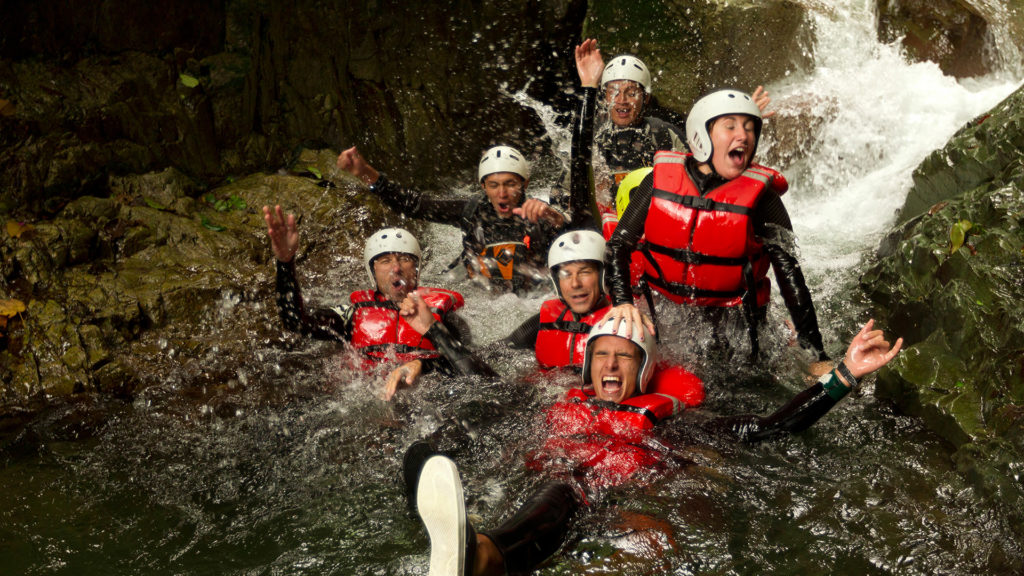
left=415, top=323, right=847, bottom=574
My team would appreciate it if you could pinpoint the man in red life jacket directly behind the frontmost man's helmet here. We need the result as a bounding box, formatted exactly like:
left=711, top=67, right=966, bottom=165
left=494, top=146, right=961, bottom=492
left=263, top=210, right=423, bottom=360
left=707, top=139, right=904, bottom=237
left=505, top=230, right=611, bottom=368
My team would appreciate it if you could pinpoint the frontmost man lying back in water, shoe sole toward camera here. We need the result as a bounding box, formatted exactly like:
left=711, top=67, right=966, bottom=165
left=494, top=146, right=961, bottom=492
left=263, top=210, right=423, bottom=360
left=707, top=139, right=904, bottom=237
left=402, top=305, right=902, bottom=575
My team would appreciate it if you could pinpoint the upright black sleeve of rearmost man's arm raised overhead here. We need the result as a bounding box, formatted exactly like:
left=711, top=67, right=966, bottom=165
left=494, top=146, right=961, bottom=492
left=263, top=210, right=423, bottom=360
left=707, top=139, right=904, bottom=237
left=569, top=87, right=601, bottom=232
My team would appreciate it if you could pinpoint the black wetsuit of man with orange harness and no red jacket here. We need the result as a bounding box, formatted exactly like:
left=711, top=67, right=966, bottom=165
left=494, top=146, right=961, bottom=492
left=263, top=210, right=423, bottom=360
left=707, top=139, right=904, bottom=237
left=370, top=174, right=560, bottom=291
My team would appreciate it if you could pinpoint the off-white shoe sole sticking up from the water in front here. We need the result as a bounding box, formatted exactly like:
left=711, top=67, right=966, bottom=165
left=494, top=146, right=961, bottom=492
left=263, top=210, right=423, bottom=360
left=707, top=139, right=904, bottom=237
left=416, top=456, right=466, bottom=576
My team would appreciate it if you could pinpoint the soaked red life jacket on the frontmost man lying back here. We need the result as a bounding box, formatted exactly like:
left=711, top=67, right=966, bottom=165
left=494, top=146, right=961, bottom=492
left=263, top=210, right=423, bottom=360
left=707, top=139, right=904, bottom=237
left=526, top=366, right=705, bottom=487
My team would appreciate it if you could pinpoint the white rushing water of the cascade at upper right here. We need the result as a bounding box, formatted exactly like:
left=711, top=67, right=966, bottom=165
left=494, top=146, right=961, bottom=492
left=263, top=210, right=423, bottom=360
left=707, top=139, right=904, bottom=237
left=765, top=0, right=1022, bottom=290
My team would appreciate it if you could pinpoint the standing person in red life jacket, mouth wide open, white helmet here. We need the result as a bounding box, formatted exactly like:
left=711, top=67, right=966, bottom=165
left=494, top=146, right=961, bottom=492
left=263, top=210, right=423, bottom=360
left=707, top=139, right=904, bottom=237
left=606, top=89, right=827, bottom=361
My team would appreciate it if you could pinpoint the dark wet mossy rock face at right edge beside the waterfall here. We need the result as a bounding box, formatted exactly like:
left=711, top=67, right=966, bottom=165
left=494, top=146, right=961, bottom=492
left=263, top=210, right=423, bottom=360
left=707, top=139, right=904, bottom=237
left=861, top=83, right=1024, bottom=537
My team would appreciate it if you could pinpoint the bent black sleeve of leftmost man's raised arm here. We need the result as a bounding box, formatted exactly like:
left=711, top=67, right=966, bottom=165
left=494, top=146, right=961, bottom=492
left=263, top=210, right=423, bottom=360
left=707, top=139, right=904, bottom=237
left=275, top=260, right=354, bottom=341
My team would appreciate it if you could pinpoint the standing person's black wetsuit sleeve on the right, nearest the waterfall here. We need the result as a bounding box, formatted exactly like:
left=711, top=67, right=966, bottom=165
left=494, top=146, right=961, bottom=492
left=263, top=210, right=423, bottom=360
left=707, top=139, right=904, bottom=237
left=754, top=191, right=828, bottom=360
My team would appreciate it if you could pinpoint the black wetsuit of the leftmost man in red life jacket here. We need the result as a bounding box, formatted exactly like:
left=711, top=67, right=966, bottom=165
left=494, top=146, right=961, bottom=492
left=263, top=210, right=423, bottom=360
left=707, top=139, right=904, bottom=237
left=274, top=260, right=468, bottom=374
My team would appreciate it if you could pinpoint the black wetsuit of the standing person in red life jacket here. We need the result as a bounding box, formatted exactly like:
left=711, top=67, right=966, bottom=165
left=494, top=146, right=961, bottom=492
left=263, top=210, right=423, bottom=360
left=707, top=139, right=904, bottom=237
left=605, top=157, right=828, bottom=360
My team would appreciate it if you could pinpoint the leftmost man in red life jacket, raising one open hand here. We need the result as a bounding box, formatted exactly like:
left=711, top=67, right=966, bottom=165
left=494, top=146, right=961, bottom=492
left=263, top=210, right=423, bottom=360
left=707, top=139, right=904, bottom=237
left=263, top=206, right=465, bottom=385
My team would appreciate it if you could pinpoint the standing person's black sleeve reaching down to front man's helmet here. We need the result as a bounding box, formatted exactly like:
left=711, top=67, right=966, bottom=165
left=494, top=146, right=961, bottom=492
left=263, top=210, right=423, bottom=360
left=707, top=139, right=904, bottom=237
left=604, top=170, right=654, bottom=306
